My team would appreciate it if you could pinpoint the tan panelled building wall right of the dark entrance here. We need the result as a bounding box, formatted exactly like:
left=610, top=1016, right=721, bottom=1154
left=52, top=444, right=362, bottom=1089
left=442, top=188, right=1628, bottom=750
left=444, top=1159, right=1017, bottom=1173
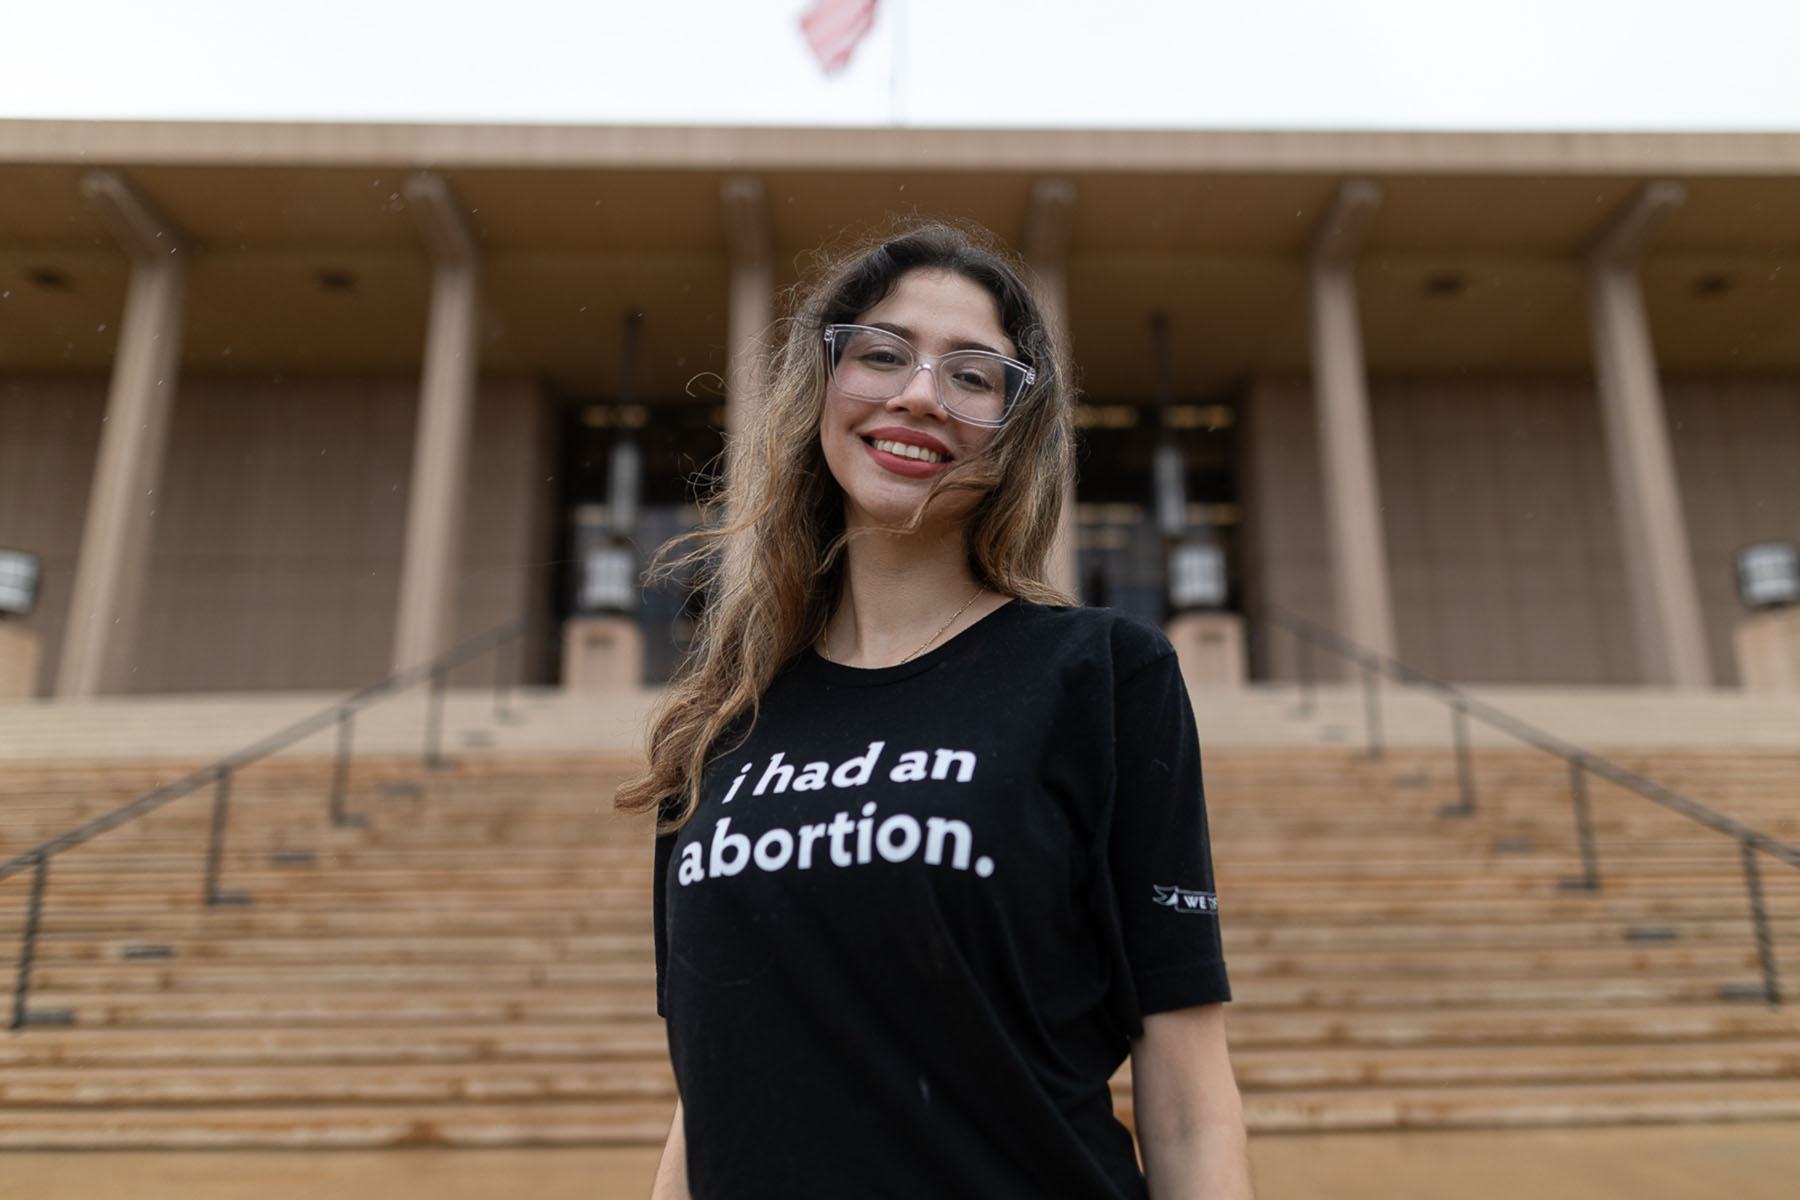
left=1246, top=376, right=1800, bottom=684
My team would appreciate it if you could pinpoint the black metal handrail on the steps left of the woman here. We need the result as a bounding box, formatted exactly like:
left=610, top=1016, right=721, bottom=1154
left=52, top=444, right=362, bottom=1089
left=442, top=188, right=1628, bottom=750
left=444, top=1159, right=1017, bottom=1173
left=0, top=619, right=538, bottom=1029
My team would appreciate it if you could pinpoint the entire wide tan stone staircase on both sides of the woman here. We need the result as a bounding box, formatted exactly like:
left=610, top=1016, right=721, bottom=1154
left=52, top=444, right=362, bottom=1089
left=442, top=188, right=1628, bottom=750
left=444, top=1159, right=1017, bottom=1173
left=0, top=747, right=1800, bottom=1148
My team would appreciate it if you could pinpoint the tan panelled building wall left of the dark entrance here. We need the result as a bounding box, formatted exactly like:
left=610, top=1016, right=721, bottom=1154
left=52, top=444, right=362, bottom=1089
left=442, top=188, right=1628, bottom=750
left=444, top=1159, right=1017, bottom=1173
left=0, top=374, right=554, bottom=694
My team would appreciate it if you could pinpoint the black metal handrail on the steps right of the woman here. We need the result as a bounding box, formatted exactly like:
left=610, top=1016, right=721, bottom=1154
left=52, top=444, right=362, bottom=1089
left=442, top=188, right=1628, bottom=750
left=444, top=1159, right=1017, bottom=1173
left=1262, top=604, right=1800, bottom=1004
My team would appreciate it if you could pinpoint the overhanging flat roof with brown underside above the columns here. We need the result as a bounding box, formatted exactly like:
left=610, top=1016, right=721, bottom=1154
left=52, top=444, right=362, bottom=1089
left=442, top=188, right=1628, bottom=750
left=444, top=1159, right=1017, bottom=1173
left=0, top=121, right=1800, bottom=394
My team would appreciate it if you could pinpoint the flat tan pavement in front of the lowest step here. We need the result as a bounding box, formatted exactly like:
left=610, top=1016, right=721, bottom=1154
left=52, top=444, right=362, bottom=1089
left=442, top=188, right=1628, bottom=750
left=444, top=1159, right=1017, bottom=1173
left=4, top=1124, right=1800, bottom=1200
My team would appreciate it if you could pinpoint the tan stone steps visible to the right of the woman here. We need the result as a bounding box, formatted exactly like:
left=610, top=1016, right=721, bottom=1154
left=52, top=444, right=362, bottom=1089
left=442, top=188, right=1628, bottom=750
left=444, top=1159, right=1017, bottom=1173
left=1180, top=750, right=1800, bottom=1130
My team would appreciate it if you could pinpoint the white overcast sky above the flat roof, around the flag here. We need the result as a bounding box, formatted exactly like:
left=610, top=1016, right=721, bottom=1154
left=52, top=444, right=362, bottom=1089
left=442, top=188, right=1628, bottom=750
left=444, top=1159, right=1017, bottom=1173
left=0, top=0, right=1800, bottom=130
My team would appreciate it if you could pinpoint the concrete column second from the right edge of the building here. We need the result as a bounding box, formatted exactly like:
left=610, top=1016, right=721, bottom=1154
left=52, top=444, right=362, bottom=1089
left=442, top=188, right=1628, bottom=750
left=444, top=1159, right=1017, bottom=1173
left=1309, top=180, right=1395, bottom=655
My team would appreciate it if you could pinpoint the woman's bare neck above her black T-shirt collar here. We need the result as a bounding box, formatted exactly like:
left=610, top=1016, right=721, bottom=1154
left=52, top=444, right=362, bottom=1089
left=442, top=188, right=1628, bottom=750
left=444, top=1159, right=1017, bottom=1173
left=824, top=525, right=1004, bottom=667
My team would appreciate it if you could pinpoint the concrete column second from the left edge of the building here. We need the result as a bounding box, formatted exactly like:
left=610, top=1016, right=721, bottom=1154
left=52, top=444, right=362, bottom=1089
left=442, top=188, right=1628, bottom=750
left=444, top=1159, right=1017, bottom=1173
left=394, top=173, right=481, bottom=671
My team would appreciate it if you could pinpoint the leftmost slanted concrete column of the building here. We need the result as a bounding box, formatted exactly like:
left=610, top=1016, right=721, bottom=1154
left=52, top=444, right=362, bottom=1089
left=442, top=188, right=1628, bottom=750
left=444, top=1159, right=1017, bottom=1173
left=56, top=171, right=187, bottom=696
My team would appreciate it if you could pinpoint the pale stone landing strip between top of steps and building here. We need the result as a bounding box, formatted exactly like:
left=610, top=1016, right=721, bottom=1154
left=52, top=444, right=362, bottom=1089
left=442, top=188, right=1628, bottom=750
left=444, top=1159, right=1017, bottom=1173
left=0, top=684, right=1800, bottom=766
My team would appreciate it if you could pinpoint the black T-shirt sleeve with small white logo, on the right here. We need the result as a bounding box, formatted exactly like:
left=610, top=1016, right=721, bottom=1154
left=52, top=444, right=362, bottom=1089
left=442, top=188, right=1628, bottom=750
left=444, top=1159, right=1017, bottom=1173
left=1107, top=642, right=1231, bottom=1020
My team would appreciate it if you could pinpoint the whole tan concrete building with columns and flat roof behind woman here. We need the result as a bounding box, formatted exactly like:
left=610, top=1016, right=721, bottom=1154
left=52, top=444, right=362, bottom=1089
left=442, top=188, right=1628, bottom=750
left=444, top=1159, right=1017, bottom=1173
left=0, top=121, right=1800, bottom=696
